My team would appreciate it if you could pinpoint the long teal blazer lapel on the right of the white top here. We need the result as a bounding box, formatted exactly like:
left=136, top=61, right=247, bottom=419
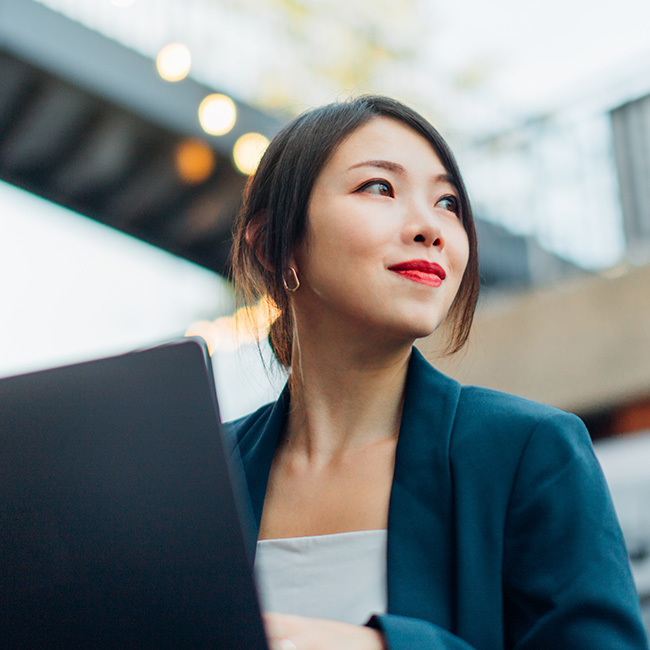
left=388, top=348, right=460, bottom=629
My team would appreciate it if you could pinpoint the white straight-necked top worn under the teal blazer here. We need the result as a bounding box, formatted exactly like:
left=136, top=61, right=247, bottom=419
left=255, top=530, right=387, bottom=625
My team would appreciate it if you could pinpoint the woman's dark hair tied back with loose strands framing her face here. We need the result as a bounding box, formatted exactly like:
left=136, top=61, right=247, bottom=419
left=231, top=95, right=479, bottom=368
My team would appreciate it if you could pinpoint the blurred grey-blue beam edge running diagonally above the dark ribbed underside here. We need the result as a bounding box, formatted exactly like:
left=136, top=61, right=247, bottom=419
left=0, top=0, right=281, bottom=156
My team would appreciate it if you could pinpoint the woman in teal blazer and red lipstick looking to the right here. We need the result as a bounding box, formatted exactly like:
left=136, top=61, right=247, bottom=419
left=227, top=97, right=646, bottom=650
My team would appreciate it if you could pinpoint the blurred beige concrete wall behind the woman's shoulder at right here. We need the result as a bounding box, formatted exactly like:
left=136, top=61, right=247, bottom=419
left=419, top=266, right=650, bottom=413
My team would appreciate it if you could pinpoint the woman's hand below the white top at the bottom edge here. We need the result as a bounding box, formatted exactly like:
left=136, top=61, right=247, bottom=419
left=264, top=614, right=385, bottom=650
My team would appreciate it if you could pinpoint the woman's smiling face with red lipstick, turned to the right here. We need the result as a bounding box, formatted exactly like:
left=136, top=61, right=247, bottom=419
left=293, top=117, right=469, bottom=339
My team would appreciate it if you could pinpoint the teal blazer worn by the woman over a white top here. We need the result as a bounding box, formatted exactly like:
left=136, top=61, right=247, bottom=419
left=231, top=349, right=648, bottom=650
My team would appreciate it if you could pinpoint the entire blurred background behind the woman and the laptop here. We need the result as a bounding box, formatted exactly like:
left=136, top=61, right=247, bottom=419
left=0, top=0, right=650, bottom=624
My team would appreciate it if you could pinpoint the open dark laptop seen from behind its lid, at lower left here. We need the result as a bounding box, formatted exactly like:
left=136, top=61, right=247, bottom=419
left=0, top=338, right=268, bottom=650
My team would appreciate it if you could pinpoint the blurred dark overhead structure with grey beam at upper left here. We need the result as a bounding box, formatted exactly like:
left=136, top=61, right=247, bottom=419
left=0, top=0, right=280, bottom=274
